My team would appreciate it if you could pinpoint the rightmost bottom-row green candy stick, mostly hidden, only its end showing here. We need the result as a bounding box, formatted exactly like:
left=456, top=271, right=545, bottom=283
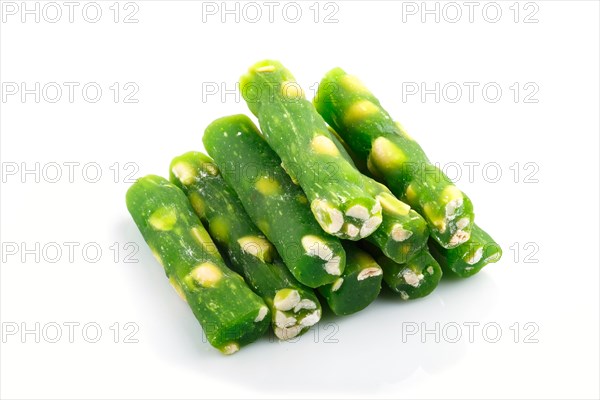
left=429, top=224, right=502, bottom=278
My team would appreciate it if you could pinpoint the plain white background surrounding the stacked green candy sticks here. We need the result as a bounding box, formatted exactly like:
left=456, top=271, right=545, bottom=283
left=0, top=1, right=600, bottom=399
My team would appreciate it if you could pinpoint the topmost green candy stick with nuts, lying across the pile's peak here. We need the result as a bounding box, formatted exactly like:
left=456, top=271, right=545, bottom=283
left=240, top=60, right=381, bottom=240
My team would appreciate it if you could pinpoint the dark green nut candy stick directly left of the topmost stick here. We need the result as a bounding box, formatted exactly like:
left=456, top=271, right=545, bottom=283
left=204, top=115, right=346, bottom=288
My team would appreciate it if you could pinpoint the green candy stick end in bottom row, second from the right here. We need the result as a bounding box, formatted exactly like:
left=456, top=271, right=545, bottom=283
left=361, top=242, right=442, bottom=300
